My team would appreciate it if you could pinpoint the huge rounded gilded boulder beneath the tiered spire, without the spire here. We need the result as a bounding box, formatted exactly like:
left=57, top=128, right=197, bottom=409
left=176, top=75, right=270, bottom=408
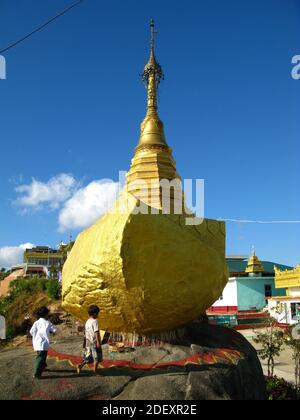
left=62, top=192, right=227, bottom=334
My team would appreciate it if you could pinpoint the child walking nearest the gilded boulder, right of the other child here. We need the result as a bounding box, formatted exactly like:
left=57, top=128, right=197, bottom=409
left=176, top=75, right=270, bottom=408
left=77, top=305, right=102, bottom=374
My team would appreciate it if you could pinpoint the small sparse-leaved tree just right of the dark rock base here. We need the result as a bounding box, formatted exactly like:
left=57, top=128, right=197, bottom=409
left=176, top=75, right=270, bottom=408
left=253, top=319, right=284, bottom=378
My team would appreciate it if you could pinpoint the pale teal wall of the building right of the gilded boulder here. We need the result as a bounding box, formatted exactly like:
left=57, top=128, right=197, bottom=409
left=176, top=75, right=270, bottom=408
left=236, top=277, right=286, bottom=311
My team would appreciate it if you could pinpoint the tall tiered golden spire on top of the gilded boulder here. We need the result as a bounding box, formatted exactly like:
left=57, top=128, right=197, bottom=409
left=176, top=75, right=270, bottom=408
left=127, top=20, right=183, bottom=209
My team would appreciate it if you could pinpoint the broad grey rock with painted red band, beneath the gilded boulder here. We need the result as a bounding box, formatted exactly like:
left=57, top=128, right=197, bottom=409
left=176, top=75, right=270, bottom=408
left=0, top=324, right=266, bottom=400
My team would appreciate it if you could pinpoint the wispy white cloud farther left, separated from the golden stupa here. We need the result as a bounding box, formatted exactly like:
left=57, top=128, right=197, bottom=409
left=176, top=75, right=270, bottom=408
left=15, top=174, right=78, bottom=210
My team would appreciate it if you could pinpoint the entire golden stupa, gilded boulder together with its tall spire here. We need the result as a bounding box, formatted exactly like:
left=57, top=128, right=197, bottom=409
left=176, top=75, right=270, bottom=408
left=62, top=21, right=227, bottom=334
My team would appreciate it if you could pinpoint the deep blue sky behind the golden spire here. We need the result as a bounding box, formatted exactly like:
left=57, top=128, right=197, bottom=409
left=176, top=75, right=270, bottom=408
left=0, top=0, right=300, bottom=265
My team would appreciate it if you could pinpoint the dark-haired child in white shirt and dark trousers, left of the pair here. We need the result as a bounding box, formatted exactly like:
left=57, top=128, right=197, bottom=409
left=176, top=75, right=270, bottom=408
left=30, top=306, right=56, bottom=379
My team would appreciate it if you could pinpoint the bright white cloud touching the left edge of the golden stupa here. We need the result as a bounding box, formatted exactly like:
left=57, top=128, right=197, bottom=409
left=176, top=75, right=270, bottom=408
left=59, top=180, right=119, bottom=232
